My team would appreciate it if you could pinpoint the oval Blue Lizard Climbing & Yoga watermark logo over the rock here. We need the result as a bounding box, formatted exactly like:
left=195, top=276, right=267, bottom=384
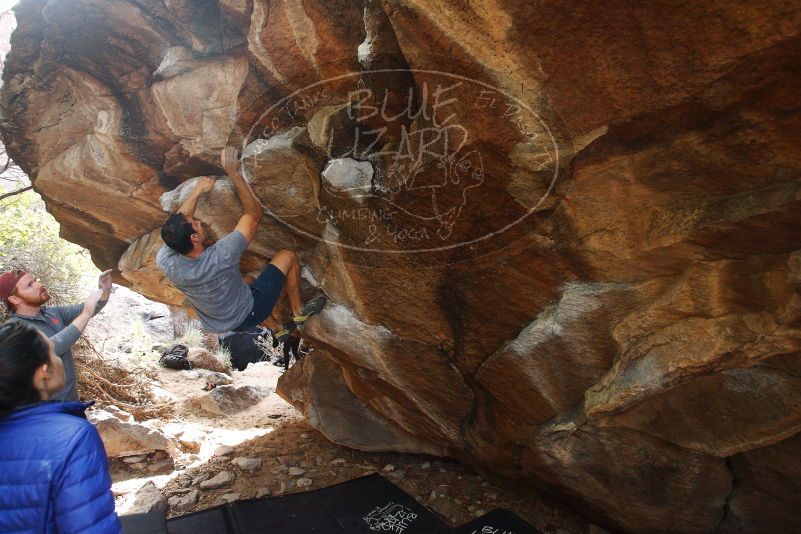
left=243, top=69, right=566, bottom=254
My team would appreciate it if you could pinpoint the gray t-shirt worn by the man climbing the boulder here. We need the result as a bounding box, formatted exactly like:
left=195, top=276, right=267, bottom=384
left=156, top=231, right=253, bottom=332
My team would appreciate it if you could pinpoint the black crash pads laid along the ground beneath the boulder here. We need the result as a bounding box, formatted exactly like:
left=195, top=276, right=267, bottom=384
left=155, top=474, right=539, bottom=534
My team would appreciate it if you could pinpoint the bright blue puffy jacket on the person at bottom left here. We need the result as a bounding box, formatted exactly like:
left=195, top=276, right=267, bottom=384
left=0, top=402, right=121, bottom=534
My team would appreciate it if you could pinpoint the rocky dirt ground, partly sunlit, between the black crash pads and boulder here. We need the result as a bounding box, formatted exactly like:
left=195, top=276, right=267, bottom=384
left=108, top=362, right=587, bottom=533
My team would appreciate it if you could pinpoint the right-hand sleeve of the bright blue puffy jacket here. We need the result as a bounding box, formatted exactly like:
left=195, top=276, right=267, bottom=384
left=52, top=421, right=122, bottom=534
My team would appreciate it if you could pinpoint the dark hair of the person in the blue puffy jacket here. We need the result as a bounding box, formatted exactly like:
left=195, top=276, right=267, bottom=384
left=0, top=321, right=50, bottom=416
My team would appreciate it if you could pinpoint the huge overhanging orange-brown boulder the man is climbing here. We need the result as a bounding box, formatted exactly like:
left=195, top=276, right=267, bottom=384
left=0, top=0, right=801, bottom=532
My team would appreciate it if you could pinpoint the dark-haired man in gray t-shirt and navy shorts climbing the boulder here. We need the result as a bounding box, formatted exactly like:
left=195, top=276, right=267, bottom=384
left=156, top=147, right=325, bottom=342
